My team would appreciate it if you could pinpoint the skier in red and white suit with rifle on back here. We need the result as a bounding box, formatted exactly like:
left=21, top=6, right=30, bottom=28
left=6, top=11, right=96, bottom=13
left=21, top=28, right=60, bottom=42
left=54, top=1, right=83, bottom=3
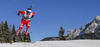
left=13, top=5, right=35, bottom=42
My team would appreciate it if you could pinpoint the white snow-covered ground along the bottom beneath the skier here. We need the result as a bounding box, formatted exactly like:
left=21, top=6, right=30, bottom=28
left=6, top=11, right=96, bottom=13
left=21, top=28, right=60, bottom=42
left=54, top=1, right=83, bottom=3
left=0, top=40, right=100, bottom=47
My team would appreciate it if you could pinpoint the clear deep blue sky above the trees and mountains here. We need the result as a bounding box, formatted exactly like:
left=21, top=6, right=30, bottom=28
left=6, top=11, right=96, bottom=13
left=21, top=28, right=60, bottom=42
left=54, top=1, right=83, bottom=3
left=0, top=0, right=100, bottom=41
